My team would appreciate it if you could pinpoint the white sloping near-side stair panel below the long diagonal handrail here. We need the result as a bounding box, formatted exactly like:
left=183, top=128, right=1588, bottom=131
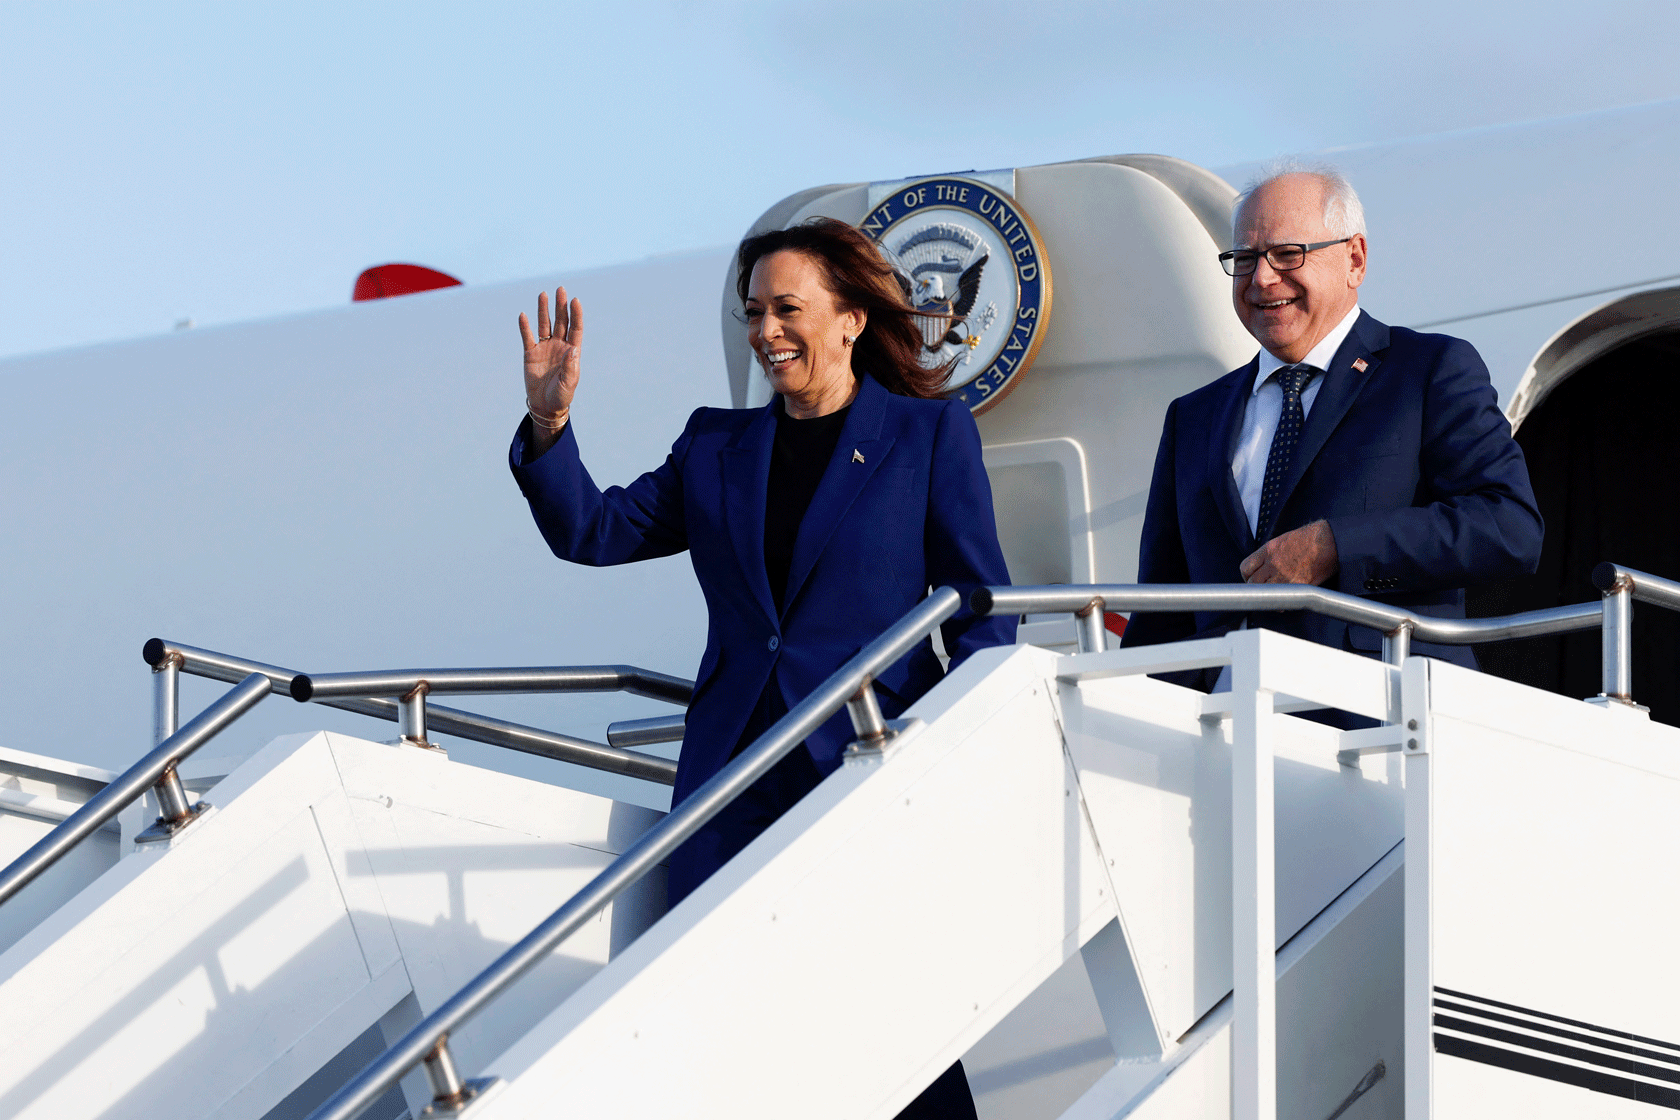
left=482, top=650, right=1112, bottom=1120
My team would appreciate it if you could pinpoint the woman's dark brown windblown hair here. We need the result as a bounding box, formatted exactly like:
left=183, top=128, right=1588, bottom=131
left=736, top=218, right=954, bottom=398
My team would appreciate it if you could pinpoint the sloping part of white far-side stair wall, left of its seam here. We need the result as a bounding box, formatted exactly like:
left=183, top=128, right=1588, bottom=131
left=0, top=737, right=378, bottom=1117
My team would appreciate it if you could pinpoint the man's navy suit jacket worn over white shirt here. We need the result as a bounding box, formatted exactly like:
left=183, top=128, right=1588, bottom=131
left=1122, top=312, right=1542, bottom=667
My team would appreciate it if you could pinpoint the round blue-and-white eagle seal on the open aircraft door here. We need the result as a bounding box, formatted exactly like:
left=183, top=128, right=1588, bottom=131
left=862, top=176, right=1050, bottom=413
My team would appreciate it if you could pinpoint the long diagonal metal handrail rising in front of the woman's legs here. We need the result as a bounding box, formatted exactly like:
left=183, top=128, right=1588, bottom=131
left=297, top=588, right=963, bottom=1120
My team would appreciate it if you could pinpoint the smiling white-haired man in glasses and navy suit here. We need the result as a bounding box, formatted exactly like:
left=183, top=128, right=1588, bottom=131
left=1122, top=168, right=1542, bottom=675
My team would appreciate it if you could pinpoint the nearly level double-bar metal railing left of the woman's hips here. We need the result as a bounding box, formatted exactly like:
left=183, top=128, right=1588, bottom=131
left=143, top=638, right=694, bottom=786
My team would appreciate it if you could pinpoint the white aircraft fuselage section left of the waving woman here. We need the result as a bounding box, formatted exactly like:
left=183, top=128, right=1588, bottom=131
left=0, top=252, right=727, bottom=808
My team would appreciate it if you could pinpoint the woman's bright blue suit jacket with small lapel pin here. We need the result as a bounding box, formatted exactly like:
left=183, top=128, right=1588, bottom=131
left=511, top=376, right=1015, bottom=801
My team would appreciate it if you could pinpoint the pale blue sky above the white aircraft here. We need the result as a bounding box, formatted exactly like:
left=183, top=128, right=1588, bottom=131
left=0, top=0, right=1680, bottom=358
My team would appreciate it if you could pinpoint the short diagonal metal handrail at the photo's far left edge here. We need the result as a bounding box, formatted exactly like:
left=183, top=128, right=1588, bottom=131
left=0, top=673, right=272, bottom=903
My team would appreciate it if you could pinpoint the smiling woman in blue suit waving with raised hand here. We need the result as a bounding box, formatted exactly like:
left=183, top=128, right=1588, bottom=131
left=509, top=218, right=1015, bottom=1120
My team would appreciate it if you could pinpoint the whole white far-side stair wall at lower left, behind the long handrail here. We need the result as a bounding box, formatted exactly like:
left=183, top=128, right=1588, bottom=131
left=0, top=734, right=664, bottom=1120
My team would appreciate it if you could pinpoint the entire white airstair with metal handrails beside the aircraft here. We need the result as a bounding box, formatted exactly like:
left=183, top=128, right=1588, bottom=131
left=0, top=566, right=1680, bottom=1120
